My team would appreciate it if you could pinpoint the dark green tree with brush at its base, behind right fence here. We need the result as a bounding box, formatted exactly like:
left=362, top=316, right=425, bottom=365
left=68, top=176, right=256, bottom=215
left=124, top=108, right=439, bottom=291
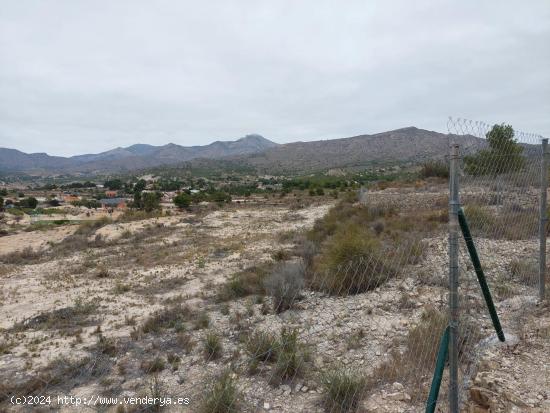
left=464, top=124, right=525, bottom=175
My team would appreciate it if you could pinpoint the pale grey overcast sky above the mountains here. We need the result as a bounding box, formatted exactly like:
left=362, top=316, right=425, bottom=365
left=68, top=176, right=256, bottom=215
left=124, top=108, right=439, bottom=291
left=0, top=0, right=550, bottom=155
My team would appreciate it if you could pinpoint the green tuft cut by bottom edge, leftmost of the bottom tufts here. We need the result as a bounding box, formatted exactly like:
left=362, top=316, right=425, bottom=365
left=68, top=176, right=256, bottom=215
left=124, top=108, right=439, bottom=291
left=200, top=370, right=241, bottom=413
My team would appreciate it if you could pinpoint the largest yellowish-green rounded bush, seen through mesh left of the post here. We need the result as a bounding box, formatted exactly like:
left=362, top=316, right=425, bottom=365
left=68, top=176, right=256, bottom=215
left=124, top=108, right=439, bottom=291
left=303, top=202, right=432, bottom=295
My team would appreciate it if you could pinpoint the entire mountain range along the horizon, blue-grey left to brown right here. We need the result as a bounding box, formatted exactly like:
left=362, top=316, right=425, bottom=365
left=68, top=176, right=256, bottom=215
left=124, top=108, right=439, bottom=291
left=0, top=127, right=483, bottom=175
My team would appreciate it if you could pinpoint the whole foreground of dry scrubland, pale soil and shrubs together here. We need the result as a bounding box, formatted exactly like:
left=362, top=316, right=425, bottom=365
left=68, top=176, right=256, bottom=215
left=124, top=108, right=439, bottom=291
left=0, top=184, right=550, bottom=413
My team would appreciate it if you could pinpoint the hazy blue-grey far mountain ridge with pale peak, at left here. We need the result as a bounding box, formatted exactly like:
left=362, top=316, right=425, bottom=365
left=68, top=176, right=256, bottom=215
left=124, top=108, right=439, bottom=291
left=0, top=135, right=278, bottom=174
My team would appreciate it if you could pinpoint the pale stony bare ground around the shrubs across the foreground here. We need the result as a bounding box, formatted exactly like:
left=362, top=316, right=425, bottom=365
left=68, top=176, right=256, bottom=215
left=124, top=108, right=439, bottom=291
left=0, top=188, right=550, bottom=413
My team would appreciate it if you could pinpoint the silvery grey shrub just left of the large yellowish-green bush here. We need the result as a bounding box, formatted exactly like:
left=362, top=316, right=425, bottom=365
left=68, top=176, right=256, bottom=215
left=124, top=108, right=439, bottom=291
left=265, top=263, right=304, bottom=313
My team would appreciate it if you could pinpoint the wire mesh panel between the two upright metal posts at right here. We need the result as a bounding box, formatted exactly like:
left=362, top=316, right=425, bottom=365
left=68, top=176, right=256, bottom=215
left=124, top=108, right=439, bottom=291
left=448, top=118, right=546, bottom=408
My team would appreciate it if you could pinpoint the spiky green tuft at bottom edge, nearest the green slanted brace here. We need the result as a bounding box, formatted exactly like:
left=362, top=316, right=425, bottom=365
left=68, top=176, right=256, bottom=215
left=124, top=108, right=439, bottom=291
left=323, top=370, right=366, bottom=413
